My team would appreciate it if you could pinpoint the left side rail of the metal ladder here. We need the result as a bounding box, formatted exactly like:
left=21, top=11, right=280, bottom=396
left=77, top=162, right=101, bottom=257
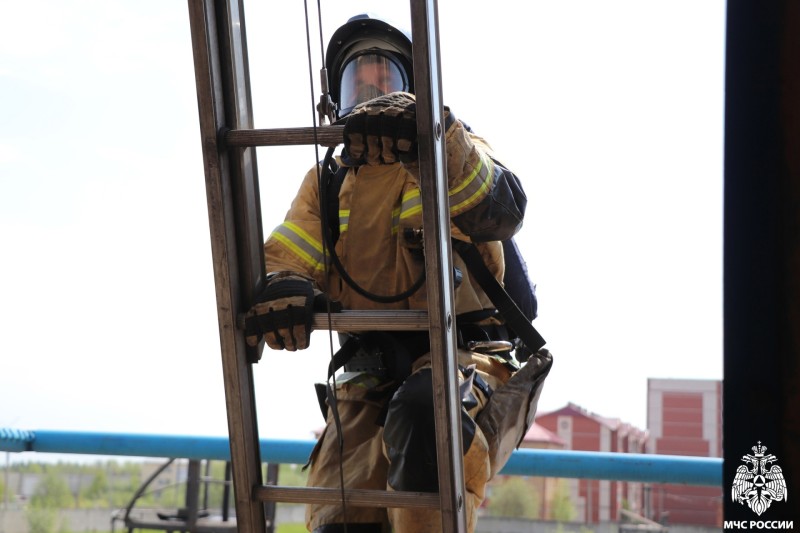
left=188, top=0, right=266, bottom=533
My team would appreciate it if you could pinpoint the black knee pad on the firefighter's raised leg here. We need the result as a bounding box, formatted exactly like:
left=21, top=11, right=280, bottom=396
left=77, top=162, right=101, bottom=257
left=383, top=368, right=475, bottom=492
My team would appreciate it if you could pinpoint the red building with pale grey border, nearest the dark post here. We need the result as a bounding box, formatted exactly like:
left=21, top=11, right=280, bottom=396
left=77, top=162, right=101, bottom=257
left=644, top=379, right=722, bottom=527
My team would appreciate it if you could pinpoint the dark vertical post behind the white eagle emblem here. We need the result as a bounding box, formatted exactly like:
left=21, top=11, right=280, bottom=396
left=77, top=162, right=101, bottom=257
left=722, top=0, right=800, bottom=521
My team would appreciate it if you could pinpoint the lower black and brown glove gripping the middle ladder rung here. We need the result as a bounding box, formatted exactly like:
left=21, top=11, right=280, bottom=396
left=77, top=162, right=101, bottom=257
left=244, top=275, right=338, bottom=352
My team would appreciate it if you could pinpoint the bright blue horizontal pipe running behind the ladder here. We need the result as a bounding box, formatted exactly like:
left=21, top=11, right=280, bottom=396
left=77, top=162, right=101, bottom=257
left=0, top=428, right=722, bottom=487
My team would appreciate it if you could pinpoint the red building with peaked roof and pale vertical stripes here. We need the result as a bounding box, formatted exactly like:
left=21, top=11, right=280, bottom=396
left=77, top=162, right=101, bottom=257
left=536, top=403, right=647, bottom=524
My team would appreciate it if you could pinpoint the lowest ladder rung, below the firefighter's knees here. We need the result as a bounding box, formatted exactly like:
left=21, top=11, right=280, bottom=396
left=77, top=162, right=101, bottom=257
left=253, top=485, right=440, bottom=509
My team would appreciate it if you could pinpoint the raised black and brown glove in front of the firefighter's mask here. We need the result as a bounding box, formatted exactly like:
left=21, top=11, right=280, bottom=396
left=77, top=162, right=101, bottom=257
left=344, top=92, right=418, bottom=166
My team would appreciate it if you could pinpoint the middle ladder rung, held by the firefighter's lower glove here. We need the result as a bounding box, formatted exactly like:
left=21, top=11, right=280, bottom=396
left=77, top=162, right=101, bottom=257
left=314, top=310, right=429, bottom=331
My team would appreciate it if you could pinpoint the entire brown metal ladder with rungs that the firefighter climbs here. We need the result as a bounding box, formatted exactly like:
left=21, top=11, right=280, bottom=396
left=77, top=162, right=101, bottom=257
left=189, top=0, right=466, bottom=533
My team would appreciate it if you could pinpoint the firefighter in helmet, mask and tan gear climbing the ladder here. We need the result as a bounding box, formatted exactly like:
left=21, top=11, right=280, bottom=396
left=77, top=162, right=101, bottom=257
left=246, top=15, right=544, bottom=533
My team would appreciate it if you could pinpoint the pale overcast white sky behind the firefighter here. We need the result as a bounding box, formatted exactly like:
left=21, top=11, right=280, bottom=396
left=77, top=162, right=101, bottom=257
left=0, top=0, right=725, bottom=460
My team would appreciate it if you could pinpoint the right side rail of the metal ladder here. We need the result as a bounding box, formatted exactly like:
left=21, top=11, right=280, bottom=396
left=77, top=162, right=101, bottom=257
left=411, top=0, right=466, bottom=533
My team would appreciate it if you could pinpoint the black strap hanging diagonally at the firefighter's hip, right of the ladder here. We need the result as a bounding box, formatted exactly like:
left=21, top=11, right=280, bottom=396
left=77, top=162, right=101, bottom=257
left=452, top=239, right=545, bottom=362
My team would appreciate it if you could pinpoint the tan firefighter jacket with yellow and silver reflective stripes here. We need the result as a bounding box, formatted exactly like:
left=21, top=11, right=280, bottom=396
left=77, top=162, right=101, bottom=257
left=264, top=121, right=524, bottom=314
